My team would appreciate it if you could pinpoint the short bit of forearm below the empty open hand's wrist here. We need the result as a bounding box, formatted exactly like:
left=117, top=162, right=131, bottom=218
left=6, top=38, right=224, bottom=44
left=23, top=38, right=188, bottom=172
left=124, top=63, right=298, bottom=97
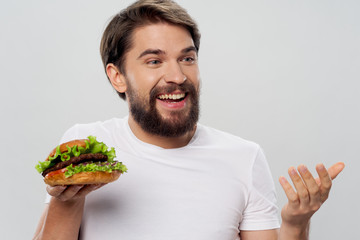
left=279, top=221, right=310, bottom=240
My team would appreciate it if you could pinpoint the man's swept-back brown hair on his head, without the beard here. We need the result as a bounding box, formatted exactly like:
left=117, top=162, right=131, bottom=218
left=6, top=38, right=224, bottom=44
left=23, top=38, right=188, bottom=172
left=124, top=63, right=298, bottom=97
left=100, top=0, right=200, bottom=99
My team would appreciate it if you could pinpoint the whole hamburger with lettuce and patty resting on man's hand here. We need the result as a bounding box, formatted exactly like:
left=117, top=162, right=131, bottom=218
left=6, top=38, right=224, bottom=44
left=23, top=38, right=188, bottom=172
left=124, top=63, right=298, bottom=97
left=35, top=136, right=127, bottom=186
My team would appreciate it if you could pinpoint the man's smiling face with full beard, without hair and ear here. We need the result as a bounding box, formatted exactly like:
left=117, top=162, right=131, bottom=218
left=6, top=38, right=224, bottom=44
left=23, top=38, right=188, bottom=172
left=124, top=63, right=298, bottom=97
left=124, top=23, right=200, bottom=137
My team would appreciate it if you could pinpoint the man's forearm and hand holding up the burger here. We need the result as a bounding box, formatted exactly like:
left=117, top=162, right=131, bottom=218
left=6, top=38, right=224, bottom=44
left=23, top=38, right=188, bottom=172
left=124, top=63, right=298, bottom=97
left=33, top=185, right=103, bottom=240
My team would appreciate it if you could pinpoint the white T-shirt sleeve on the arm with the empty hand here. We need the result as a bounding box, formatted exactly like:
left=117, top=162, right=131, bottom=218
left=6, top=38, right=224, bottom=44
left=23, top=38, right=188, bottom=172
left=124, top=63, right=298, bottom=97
left=239, top=148, right=280, bottom=231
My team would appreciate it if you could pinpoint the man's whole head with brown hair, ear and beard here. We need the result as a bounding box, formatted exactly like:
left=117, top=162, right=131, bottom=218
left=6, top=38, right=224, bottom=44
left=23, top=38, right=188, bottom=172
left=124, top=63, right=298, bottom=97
left=101, top=0, right=200, bottom=137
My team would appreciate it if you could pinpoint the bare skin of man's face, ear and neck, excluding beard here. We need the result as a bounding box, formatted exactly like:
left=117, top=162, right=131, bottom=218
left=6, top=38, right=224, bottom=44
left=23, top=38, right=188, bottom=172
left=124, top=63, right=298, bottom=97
left=106, top=23, right=200, bottom=148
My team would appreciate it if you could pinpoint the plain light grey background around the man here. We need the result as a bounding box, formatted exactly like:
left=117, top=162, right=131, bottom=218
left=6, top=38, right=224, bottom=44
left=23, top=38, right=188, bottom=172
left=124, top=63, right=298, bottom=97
left=0, top=0, right=360, bottom=240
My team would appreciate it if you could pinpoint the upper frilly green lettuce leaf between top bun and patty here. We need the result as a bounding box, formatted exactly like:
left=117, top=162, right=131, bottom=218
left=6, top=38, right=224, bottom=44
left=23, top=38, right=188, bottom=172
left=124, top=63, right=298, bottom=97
left=35, top=136, right=121, bottom=173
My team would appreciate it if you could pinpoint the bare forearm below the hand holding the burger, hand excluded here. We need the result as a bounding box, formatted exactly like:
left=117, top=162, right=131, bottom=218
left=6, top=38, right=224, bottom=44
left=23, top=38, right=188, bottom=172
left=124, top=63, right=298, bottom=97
left=34, top=197, right=85, bottom=240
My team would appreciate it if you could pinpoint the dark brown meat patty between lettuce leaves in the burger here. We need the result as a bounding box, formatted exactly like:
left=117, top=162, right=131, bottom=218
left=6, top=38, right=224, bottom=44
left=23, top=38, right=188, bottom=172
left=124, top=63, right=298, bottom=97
left=42, top=153, right=108, bottom=177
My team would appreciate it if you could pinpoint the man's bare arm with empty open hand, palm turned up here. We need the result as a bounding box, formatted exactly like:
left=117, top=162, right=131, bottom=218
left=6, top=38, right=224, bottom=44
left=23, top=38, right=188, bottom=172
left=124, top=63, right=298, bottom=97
left=240, top=162, right=345, bottom=240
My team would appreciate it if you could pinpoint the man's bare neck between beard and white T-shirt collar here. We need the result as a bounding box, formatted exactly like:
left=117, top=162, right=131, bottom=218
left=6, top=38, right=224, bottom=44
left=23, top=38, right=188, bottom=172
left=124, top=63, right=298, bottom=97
left=128, top=115, right=196, bottom=149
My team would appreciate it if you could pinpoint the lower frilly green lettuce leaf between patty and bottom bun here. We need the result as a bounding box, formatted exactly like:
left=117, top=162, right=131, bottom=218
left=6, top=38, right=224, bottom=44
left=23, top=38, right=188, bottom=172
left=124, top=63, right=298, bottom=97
left=65, top=162, right=127, bottom=177
